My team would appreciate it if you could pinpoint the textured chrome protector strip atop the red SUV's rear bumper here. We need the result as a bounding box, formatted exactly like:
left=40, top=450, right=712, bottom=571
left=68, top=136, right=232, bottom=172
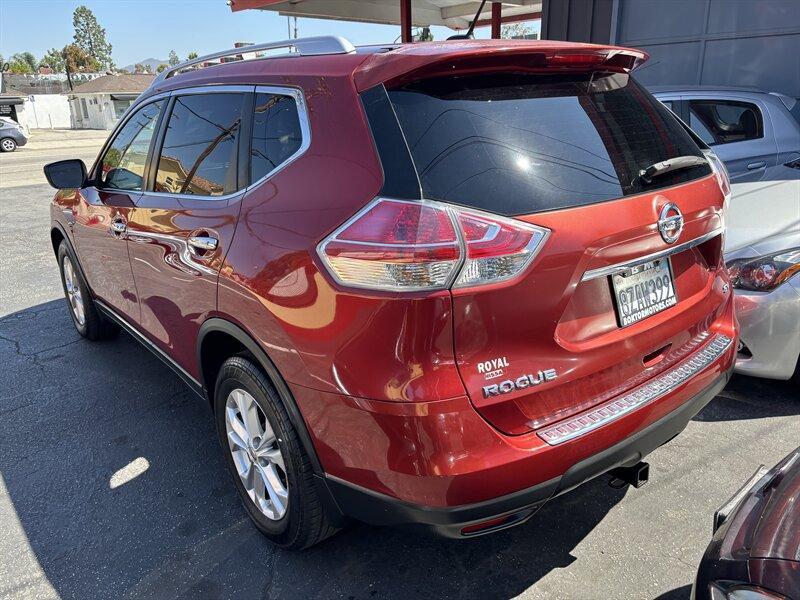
left=537, top=334, right=733, bottom=446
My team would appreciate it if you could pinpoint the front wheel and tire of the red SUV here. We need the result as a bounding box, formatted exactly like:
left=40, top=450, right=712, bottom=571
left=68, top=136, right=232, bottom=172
left=58, top=241, right=119, bottom=341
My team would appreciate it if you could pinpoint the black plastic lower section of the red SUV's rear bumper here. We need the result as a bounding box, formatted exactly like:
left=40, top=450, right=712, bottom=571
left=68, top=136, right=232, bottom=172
left=320, top=368, right=732, bottom=538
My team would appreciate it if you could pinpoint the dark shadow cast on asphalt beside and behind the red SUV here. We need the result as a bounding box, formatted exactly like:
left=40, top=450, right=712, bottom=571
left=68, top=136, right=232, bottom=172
left=0, top=300, right=797, bottom=600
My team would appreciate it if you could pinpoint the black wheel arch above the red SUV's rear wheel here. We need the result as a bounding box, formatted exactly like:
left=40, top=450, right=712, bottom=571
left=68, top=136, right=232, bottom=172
left=196, top=317, right=324, bottom=475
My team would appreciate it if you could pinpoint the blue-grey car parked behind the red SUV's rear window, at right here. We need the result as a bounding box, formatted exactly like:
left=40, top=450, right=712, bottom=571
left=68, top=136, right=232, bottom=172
left=650, top=87, right=800, bottom=183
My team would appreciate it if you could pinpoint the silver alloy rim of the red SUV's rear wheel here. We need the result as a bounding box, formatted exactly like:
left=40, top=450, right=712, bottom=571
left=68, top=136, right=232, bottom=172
left=225, top=388, right=289, bottom=521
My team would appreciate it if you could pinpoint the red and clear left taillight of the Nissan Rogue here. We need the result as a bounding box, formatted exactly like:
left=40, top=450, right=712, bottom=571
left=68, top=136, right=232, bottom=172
left=317, top=198, right=547, bottom=292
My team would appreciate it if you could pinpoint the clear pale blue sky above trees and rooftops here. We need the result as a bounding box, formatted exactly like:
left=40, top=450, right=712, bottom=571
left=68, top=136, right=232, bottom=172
left=0, top=0, right=540, bottom=67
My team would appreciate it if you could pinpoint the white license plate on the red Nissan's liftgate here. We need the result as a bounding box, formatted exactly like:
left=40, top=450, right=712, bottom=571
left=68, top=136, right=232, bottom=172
left=611, top=258, right=678, bottom=327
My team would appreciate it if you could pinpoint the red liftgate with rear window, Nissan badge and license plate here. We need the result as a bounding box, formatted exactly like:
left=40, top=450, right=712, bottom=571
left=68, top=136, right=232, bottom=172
left=388, top=73, right=724, bottom=434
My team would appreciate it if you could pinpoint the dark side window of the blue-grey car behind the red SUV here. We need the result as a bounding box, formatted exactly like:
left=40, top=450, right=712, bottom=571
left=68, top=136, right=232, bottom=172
left=689, top=100, right=764, bottom=145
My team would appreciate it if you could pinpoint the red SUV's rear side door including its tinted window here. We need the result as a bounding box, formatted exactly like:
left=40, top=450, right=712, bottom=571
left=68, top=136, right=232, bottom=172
left=127, top=86, right=253, bottom=378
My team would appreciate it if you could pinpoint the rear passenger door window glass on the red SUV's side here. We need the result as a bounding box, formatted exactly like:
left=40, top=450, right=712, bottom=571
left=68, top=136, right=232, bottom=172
left=155, top=93, right=245, bottom=196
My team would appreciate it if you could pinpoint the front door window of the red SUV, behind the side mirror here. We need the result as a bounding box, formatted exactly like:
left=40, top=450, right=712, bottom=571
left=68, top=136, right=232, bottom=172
left=100, top=100, right=164, bottom=191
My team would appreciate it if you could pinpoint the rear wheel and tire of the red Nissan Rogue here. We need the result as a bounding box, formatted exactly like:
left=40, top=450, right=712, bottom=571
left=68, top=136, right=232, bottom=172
left=214, top=356, right=338, bottom=550
